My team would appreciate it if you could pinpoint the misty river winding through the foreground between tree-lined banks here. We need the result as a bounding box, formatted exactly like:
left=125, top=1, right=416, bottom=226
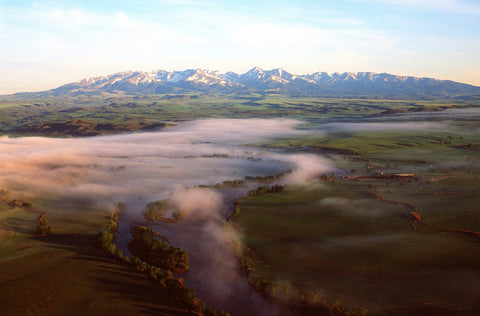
left=116, top=186, right=290, bottom=315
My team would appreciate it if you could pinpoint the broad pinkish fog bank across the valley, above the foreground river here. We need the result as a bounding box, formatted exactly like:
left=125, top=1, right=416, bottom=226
left=0, top=119, right=326, bottom=205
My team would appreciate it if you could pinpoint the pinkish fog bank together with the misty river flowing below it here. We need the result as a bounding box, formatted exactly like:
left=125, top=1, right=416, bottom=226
left=0, top=119, right=332, bottom=315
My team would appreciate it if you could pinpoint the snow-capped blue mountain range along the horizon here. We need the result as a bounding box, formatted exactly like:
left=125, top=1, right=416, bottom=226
left=40, top=67, right=480, bottom=98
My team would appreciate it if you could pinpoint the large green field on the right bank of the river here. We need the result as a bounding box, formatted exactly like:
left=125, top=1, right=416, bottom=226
left=232, top=111, right=480, bottom=315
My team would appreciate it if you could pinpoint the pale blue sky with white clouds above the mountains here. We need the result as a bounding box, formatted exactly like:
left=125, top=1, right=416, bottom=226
left=0, top=0, right=480, bottom=94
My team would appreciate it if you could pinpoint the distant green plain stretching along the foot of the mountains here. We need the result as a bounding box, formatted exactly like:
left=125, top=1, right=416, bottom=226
left=0, top=94, right=478, bottom=135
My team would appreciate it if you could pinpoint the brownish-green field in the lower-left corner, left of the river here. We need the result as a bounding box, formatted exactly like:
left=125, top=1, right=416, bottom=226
left=0, top=199, right=190, bottom=315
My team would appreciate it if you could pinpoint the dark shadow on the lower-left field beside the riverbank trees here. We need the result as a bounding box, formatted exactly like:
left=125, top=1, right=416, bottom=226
left=32, top=234, right=191, bottom=315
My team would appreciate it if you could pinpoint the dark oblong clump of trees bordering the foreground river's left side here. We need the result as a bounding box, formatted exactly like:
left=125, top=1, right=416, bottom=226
left=128, top=226, right=190, bottom=272
